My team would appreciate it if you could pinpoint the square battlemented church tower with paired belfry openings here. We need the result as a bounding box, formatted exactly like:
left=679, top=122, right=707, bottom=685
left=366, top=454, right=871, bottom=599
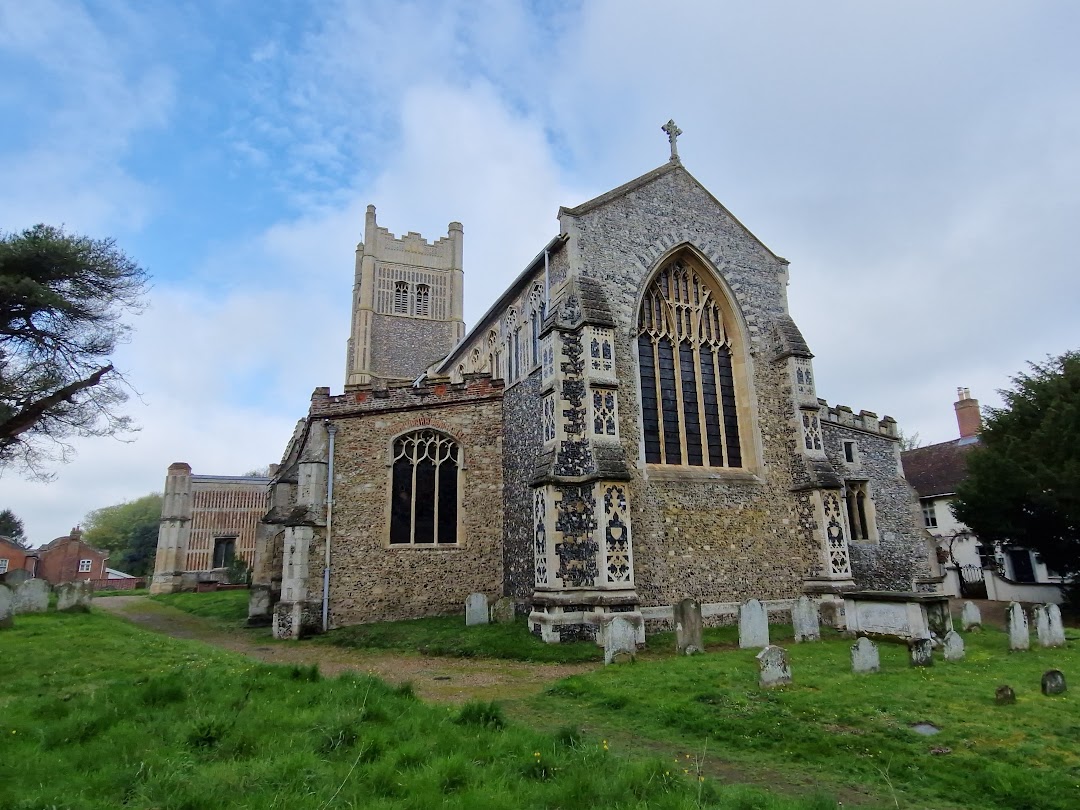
left=346, top=205, right=465, bottom=387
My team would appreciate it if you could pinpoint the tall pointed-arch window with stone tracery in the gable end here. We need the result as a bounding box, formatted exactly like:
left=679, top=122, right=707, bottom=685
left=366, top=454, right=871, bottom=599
left=637, top=258, right=743, bottom=467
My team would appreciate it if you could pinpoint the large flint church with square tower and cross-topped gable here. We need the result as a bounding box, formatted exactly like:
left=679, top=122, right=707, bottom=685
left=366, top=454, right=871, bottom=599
left=251, top=123, right=929, bottom=642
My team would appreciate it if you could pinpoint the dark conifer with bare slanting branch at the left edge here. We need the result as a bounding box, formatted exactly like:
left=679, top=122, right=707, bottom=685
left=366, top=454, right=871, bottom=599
left=0, top=225, right=147, bottom=477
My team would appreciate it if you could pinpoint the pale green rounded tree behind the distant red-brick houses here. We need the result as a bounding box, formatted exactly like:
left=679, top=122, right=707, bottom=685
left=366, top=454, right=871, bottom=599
left=82, top=492, right=162, bottom=577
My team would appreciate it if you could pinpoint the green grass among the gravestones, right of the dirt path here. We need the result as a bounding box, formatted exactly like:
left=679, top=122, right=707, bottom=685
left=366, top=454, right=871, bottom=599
left=530, top=627, right=1080, bottom=810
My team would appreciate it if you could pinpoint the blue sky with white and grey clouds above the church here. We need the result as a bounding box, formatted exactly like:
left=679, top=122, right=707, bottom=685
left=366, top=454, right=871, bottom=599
left=0, top=0, right=1080, bottom=545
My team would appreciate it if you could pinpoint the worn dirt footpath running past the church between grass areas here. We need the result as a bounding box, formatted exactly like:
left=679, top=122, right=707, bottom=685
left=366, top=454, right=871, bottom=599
left=94, top=596, right=596, bottom=703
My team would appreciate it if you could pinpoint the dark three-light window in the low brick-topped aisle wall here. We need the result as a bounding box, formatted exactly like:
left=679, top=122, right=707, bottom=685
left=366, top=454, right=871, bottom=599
left=390, top=429, right=461, bottom=545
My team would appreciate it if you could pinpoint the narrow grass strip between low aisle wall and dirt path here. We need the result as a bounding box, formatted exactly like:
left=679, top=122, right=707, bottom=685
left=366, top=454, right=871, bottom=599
left=319, top=616, right=604, bottom=663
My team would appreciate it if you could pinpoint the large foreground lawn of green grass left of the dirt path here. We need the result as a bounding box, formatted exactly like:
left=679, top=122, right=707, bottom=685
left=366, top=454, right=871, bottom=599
left=0, top=612, right=835, bottom=810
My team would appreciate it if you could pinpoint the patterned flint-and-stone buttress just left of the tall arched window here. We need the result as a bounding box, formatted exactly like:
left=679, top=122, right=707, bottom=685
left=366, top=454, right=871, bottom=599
left=529, top=276, right=645, bottom=644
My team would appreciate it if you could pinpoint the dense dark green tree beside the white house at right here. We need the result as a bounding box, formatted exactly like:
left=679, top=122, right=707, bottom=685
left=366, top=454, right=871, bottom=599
left=953, top=351, right=1080, bottom=575
